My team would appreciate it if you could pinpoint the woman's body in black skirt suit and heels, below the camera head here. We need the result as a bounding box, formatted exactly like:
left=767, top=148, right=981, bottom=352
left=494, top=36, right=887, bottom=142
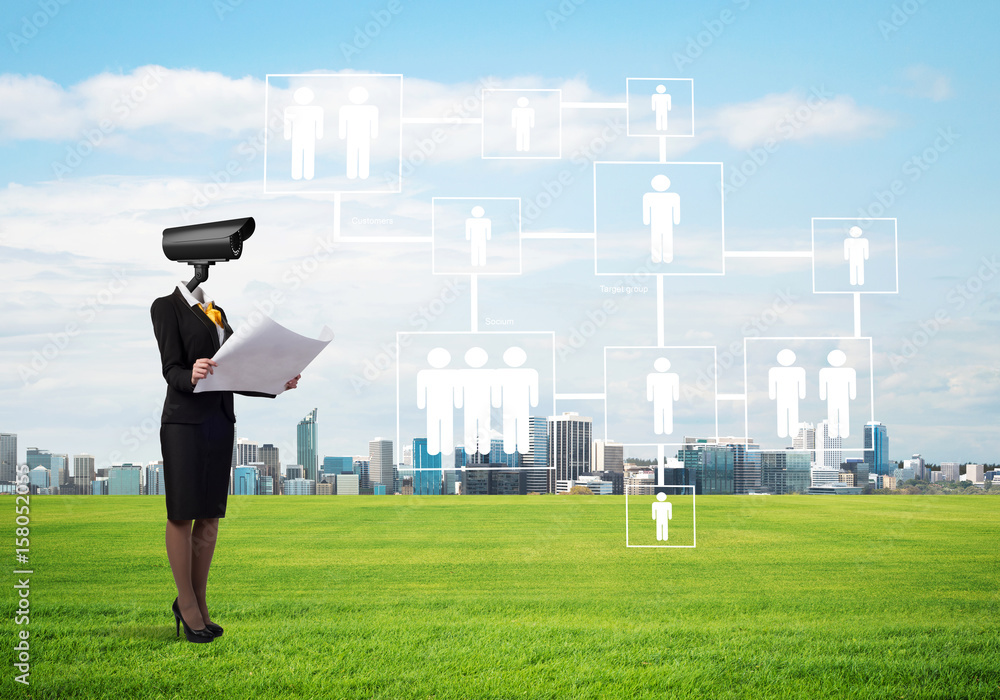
left=150, top=283, right=299, bottom=642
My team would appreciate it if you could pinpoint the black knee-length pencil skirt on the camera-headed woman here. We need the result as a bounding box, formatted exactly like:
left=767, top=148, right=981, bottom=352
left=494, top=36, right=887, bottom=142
left=160, top=411, right=235, bottom=520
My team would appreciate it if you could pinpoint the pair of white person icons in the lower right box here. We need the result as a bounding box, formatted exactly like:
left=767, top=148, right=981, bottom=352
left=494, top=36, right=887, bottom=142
left=767, top=348, right=858, bottom=438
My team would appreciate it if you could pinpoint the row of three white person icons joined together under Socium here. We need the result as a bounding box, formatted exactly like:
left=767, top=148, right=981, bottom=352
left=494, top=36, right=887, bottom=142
left=417, top=346, right=538, bottom=455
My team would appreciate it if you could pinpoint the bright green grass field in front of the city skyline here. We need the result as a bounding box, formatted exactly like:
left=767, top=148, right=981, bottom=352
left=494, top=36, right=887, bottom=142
left=0, top=496, right=1000, bottom=699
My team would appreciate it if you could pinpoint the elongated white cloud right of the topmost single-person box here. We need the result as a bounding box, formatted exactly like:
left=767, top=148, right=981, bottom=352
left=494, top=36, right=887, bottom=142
left=701, top=88, right=893, bottom=148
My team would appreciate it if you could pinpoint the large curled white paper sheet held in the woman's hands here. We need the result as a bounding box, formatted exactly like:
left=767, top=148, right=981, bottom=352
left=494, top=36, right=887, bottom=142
left=194, top=316, right=333, bottom=394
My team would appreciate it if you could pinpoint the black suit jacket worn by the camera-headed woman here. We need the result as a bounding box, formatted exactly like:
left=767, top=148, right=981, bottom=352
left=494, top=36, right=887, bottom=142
left=149, top=289, right=274, bottom=423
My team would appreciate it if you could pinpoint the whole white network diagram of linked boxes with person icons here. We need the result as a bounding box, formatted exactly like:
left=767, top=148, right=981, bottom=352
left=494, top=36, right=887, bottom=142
left=264, top=73, right=898, bottom=547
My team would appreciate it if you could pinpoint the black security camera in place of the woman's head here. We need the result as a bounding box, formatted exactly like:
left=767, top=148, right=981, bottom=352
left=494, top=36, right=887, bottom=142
left=163, top=217, right=255, bottom=291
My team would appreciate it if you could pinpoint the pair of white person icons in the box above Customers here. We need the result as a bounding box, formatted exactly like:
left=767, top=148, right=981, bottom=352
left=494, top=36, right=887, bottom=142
left=284, top=85, right=379, bottom=180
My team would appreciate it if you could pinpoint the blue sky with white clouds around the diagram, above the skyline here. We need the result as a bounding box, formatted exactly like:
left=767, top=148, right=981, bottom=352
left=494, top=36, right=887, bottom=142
left=0, top=0, right=1000, bottom=464
